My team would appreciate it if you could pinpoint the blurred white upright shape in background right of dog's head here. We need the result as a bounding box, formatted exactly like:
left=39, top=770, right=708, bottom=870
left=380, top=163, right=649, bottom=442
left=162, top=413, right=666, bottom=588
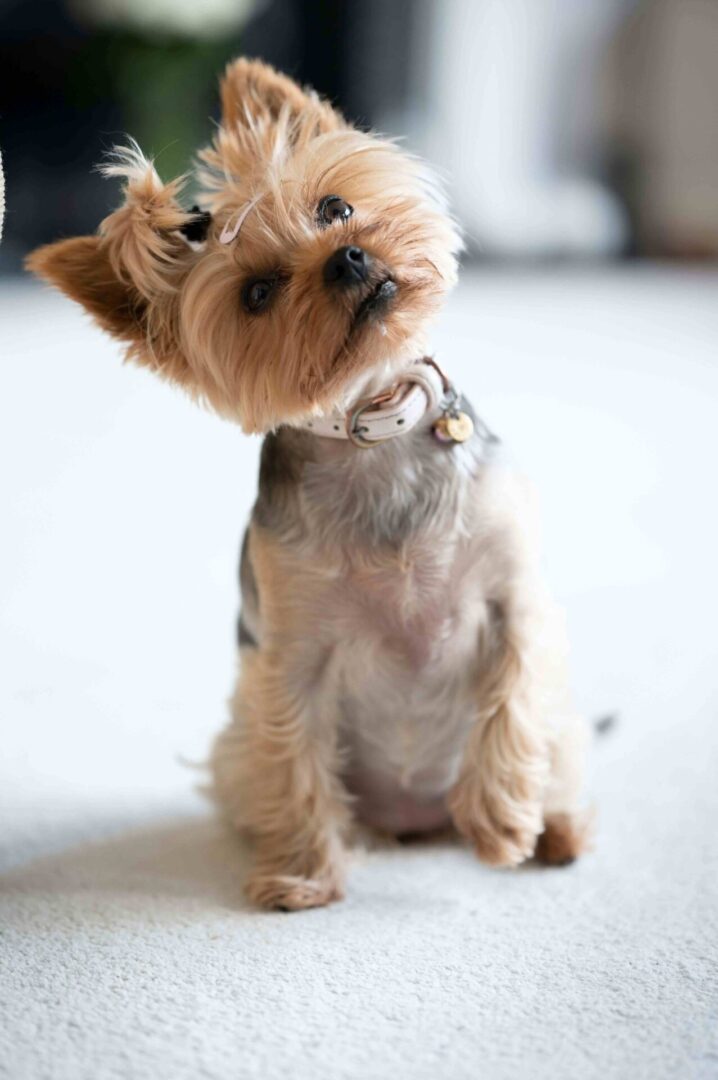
left=416, top=0, right=633, bottom=257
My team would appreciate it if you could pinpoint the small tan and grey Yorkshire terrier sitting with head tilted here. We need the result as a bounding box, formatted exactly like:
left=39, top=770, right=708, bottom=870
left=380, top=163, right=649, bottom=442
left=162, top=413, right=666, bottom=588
left=29, top=59, right=588, bottom=909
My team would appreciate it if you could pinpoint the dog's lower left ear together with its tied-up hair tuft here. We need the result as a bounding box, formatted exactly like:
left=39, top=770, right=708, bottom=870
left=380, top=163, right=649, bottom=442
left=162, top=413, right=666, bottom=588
left=27, top=145, right=206, bottom=393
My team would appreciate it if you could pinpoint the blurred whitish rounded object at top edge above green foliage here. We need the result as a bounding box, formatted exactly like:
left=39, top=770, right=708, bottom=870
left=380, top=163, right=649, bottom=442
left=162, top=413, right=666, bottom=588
left=74, top=0, right=261, bottom=38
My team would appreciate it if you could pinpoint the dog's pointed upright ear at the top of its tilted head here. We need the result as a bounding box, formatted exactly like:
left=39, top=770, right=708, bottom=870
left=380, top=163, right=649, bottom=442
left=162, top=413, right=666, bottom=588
left=220, top=57, right=344, bottom=134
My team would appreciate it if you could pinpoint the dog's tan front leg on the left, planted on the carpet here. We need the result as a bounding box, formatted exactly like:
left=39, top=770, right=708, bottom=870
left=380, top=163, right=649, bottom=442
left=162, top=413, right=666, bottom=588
left=213, top=648, right=348, bottom=910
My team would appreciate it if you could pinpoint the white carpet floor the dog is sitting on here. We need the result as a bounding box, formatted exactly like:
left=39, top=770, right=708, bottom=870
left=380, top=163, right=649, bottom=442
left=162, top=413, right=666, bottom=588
left=0, top=269, right=718, bottom=1080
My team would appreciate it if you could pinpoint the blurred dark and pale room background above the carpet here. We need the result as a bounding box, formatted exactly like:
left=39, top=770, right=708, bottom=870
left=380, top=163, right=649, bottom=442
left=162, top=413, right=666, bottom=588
left=0, top=0, right=718, bottom=274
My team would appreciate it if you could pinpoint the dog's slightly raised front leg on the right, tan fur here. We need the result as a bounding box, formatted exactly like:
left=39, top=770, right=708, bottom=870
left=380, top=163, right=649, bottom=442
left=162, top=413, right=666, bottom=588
left=449, top=602, right=550, bottom=866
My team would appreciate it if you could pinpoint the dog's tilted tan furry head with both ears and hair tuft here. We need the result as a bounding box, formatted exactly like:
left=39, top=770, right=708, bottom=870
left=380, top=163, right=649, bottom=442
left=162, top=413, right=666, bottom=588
left=28, top=59, right=460, bottom=431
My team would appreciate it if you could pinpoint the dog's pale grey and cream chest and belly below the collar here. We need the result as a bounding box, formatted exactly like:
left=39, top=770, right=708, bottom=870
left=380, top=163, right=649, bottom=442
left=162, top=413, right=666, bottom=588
left=255, top=421, right=498, bottom=831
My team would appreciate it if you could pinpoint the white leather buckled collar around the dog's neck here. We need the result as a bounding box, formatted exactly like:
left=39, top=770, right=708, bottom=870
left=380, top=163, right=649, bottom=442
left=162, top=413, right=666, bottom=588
left=302, top=360, right=449, bottom=448
